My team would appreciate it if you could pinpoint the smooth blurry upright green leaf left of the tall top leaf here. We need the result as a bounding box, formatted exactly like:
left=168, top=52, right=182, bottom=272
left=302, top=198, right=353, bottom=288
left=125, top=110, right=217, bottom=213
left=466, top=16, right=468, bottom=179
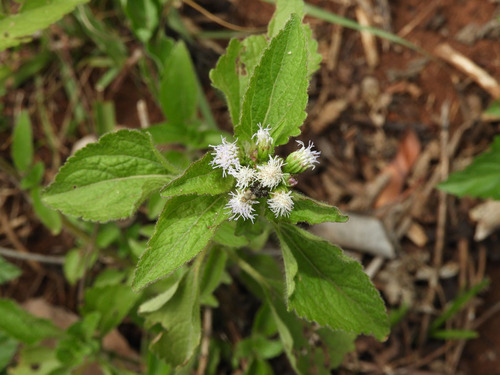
left=160, top=42, right=198, bottom=126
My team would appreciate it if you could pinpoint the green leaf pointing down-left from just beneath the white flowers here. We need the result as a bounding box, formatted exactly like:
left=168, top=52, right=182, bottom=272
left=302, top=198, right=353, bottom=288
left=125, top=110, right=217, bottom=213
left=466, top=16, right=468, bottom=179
left=133, top=194, right=229, bottom=290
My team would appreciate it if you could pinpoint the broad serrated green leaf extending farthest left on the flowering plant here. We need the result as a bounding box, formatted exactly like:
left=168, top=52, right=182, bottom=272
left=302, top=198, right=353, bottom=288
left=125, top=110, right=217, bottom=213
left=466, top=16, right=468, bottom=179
left=43, top=130, right=170, bottom=221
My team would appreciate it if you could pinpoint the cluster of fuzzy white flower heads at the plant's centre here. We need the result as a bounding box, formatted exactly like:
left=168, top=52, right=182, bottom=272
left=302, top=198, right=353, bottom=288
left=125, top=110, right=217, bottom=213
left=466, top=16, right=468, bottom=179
left=210, top=124, right=320, bottom=222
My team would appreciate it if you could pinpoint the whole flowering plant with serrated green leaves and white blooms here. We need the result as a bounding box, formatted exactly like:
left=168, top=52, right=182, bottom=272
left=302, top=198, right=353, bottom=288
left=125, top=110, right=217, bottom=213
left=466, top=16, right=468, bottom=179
left=43, top=1, right=389, bottom=373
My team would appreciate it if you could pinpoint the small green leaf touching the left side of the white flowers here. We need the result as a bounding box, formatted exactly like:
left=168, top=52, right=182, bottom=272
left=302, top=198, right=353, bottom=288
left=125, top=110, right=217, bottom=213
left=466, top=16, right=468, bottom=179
left=161, top=153, right=234, bottom=197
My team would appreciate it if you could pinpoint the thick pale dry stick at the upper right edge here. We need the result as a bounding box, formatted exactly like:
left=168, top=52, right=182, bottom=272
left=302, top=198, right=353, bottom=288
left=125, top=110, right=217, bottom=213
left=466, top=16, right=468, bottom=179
left=434, top=43, right=500, bottom=99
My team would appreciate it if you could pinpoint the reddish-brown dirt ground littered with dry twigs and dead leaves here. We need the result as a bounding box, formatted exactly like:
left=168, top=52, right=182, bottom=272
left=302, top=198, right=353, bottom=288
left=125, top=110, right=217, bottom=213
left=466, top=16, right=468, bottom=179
left=0, top=0, right=500, bottom=375
